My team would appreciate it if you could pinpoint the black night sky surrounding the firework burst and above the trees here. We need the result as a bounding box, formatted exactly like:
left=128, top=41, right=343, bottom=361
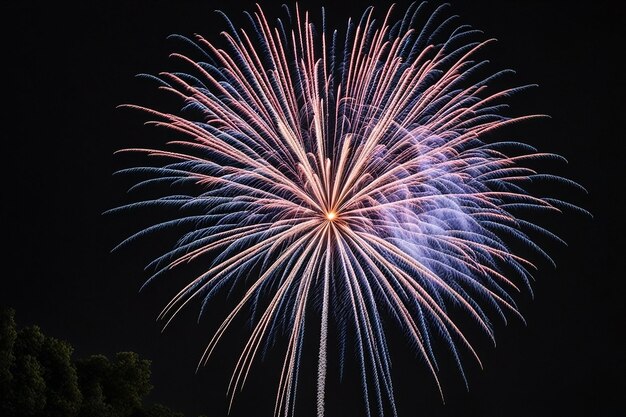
left=0, top=0, right=626, bottom=417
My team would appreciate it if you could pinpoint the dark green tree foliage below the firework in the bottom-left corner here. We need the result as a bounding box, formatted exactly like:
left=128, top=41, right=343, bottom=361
left=0, top=306, right=204, bottom=417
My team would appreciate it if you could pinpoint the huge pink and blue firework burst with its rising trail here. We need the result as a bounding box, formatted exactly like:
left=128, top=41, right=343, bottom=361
left=112, top=4, right=579, bottom=417
